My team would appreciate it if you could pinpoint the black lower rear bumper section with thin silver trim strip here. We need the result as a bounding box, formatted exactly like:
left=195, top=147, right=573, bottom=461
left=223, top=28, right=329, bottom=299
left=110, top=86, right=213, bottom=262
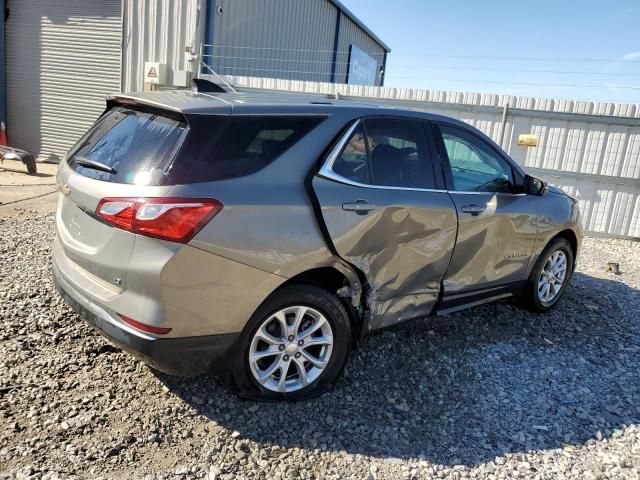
left=53, top=258, right=239, bottom=376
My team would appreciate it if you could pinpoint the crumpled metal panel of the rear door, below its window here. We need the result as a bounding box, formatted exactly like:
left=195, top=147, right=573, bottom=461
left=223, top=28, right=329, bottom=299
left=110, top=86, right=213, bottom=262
left=313, top=176, right=457, bottom=329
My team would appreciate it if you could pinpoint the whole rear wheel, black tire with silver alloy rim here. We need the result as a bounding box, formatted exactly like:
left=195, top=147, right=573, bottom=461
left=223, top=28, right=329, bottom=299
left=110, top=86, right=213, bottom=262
left=231, top=284, right=352, bottom=400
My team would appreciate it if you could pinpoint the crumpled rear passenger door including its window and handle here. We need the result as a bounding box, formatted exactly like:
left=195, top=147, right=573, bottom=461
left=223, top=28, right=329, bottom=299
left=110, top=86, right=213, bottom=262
left=313, top=117, right=456, bottom=328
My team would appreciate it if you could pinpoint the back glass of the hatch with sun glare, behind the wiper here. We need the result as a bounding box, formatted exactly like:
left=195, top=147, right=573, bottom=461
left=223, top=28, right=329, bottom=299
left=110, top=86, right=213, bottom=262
left=69, top=107, right=188, bottom=185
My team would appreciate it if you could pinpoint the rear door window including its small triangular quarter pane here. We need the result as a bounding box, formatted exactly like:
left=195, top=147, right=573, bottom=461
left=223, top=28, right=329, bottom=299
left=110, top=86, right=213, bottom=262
left=332, top=118, right=435, bottom=188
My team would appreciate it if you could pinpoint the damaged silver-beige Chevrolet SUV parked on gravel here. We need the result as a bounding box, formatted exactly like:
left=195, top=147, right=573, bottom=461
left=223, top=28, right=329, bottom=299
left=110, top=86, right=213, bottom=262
left=53, top=84, right=581, bottom=399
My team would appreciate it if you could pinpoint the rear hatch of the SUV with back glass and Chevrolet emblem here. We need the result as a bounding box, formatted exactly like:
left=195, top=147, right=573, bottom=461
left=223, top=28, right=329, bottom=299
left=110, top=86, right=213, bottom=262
left=56, top=104, right=189, bottom=291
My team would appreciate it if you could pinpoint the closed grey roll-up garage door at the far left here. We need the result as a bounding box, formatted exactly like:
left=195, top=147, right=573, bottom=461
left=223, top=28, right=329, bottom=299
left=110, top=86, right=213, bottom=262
left=6, top=0, right=122, bottom=161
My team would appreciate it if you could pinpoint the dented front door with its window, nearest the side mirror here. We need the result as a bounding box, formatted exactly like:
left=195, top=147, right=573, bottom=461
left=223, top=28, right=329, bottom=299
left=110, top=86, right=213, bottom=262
left=434, top=123, right=537, bottom=303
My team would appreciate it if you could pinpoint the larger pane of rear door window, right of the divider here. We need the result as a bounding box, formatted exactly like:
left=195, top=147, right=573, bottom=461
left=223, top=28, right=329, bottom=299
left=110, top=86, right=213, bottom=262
left=365, top=118, right=434, bottom=188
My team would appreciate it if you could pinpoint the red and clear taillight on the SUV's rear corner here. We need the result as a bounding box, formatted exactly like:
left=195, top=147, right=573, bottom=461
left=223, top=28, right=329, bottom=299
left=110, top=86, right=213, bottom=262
left=96, top=198, right=222, bottom=243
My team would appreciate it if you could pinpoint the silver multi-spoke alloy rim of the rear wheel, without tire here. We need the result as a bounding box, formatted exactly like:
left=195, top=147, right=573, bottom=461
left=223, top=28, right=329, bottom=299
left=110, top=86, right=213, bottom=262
left=249, top=305, right=334, bottom=393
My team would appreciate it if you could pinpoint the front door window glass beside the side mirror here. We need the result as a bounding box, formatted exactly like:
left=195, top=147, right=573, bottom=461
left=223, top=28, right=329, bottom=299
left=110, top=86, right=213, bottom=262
left=440, top=125, right=514, bottom=192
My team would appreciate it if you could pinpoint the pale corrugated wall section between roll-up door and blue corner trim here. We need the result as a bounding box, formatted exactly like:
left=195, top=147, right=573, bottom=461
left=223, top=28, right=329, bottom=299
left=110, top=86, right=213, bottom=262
left=122, top=0, right=200, bottom=92
